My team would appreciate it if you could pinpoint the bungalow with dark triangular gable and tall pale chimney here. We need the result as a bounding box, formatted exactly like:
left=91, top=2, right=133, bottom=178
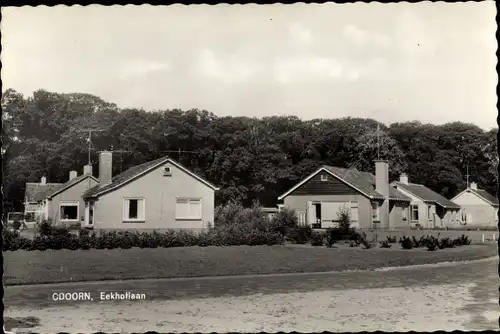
left=278, top=160, right=410, bottom=229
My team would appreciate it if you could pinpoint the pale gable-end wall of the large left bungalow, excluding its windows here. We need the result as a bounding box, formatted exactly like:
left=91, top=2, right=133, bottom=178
left=94, top=162, right=215, bottom=230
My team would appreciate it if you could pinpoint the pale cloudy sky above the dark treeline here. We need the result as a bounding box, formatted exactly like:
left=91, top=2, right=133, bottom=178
left=1, top=1, right=498, bottom=130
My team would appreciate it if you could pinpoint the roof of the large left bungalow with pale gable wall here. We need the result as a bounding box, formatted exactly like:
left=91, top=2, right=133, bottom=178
left=83, top=157, right=219, bottom=198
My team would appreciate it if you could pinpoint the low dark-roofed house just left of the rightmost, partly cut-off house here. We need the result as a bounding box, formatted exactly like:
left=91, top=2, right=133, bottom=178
left=392, top=174, right=460, bottom=228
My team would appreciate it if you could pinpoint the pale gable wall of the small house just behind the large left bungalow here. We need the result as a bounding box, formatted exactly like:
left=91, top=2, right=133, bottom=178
left=48, top=178, right=98, bottom=223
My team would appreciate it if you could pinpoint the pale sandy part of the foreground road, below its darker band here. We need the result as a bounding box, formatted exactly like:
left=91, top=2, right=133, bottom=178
left=7, top=285, right=493, bottom=333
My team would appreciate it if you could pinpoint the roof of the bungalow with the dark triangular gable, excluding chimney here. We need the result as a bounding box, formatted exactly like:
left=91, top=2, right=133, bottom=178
left=278, top=166, right=411, bottom=202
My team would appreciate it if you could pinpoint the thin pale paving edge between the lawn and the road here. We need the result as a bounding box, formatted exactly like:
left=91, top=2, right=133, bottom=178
left=4, top=256, right=499, bottom=289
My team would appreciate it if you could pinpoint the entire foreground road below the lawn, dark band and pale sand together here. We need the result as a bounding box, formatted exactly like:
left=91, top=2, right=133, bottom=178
left=4, top=260, right=499, bottom=333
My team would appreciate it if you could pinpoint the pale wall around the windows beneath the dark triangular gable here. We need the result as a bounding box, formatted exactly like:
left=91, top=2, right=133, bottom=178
left=283, top=192, right=372, bottom=228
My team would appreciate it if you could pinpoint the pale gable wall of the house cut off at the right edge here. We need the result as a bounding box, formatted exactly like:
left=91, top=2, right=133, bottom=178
left=453, top=192, right=498, bottom=226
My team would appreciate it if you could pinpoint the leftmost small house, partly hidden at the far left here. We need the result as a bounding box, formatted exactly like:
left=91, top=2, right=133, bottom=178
left=24, top=176, right=62, bottom=227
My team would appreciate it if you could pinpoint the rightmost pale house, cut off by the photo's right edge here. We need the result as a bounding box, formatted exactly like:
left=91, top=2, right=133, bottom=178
left=451, top=182, right=498, bottom=227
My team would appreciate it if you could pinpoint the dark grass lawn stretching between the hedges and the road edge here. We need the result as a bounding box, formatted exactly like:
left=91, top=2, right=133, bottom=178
left=4, top=244, right=497, bottom=285
